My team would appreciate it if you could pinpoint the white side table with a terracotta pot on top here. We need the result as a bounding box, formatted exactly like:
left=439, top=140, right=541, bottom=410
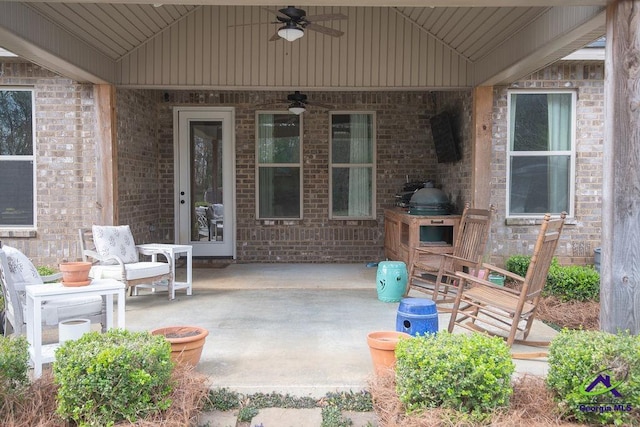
left=25, top=279, right=125, bottom=378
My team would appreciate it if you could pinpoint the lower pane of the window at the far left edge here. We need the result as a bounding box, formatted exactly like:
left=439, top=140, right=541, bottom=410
left=0, top=160, right=34, bottom=226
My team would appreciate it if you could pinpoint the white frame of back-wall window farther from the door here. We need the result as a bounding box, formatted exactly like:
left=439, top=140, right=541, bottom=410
left=329, top=111, right=377, bottom=221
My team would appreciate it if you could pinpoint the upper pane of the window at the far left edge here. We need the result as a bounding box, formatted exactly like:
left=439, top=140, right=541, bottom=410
left=0, top=90, right=33, bottom=156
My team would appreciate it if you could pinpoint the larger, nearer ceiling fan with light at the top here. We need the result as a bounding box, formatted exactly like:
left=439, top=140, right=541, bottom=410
left=232, top=6, right=347, bottom=42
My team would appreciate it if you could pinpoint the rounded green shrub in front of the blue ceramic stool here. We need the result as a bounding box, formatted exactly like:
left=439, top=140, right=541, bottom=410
left=396, top=332, right=515, bottom=420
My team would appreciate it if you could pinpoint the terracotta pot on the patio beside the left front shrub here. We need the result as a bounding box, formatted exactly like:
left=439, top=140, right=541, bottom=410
left=151, top=326, right=209, bottom=366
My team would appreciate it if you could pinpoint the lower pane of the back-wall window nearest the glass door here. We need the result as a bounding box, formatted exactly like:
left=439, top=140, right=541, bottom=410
left=258, top=167, right=300, bottom=218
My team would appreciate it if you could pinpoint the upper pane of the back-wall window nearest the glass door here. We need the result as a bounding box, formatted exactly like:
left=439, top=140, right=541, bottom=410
left=258, top=114, right=300, bottom=163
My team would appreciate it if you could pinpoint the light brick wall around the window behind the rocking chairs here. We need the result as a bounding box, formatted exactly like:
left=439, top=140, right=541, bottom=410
left=490, top=62, right=604, bottom=264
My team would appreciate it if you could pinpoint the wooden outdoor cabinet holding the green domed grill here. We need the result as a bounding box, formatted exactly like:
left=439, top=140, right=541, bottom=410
left=384, top=208, right=460, bottom=268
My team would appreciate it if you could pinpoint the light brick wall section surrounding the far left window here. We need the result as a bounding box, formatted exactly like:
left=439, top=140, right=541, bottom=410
left=0, top=62, right=96, bottom=267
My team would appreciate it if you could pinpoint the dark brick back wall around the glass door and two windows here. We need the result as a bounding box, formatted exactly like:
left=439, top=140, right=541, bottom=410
left=153, top=91, right=468, bottom=262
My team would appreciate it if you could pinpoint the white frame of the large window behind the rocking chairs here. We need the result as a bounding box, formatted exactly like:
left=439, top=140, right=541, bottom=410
left=505, top=89, right=578, bottom=219
